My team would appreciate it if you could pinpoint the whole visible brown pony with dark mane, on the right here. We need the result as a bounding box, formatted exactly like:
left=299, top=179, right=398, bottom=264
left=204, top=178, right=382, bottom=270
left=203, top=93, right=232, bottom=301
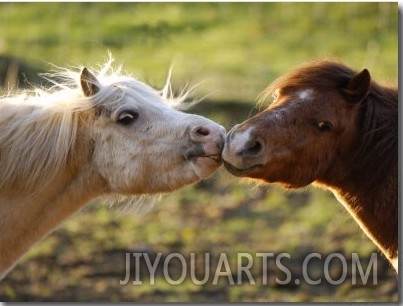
left=222, top=61, right=398, bottom=271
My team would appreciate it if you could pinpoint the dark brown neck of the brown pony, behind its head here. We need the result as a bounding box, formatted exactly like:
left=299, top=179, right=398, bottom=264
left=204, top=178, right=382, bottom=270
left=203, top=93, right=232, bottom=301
left=317, top=83, right=398, bottom=271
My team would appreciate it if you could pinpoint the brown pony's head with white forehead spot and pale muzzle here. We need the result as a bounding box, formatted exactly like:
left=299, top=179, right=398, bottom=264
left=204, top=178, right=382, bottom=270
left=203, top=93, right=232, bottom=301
left=222, top=62, right=371, bottom=188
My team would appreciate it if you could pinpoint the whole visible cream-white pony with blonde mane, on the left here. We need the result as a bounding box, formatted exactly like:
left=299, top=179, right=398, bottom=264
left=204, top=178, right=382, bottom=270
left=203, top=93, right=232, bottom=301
left=0, top=60, right=225, bottom=279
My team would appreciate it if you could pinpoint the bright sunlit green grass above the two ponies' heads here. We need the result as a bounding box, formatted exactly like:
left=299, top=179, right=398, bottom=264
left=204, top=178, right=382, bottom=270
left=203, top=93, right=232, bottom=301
left=0, top=3, right=398, bottom=103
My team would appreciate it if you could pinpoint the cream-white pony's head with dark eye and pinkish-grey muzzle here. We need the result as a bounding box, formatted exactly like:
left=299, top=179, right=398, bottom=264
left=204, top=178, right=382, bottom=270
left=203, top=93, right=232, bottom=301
left=79, top=63, right=225, bottom=194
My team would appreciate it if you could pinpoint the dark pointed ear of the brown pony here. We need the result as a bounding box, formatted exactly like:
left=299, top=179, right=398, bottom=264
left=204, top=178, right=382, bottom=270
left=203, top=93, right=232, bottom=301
left=343, top=69, right=371, bottom=103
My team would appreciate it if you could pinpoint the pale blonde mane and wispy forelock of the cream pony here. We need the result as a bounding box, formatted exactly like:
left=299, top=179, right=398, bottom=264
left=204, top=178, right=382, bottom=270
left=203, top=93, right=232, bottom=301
left=0, top=58, right=189, bottom=192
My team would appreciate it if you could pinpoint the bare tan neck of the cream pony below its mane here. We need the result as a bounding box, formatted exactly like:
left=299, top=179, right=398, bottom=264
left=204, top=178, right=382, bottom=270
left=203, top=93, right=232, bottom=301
left=0, top=163, right=104, bottom=280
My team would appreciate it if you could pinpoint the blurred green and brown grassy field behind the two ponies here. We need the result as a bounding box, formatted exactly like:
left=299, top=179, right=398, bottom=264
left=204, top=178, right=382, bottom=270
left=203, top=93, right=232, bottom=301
left=0, top=3, right=398, bottom=302
